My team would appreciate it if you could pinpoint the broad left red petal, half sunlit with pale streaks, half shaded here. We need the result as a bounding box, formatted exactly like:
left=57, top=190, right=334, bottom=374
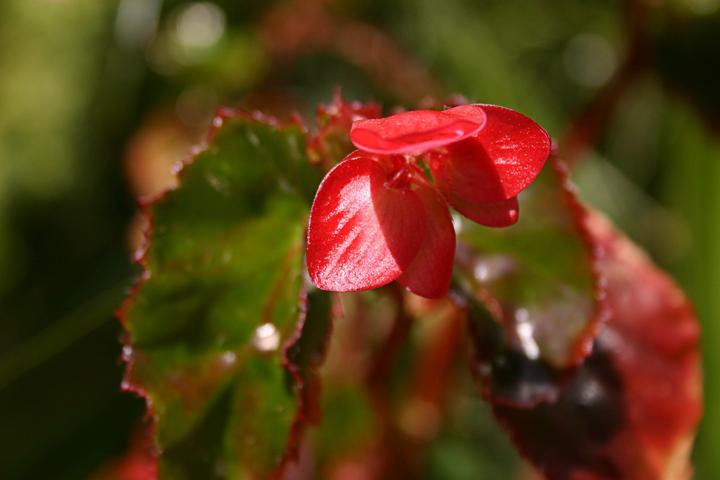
left=307, top=151, right=426, bottom=291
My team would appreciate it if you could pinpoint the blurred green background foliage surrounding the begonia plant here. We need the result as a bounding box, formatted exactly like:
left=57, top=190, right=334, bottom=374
left=0, top=0, right=720, bottom=479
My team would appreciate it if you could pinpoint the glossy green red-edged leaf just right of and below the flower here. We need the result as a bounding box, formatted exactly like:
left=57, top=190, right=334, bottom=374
left=456, top=159, right=602, bottom=376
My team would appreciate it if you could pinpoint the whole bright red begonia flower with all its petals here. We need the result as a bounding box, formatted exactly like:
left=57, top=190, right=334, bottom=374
left=307, top=105, right=550, bottom=298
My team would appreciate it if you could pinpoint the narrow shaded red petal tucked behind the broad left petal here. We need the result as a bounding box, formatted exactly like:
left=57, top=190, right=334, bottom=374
left=397, top=182, right=455, bottom=298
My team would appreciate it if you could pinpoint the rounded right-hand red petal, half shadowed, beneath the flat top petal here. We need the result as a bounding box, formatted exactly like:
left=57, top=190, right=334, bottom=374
left=431, top=105, right=550, bottom=202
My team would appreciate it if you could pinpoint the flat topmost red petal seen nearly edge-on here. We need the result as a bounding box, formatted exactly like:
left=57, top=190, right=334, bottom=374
left=350, top=110, right=485, bottom=155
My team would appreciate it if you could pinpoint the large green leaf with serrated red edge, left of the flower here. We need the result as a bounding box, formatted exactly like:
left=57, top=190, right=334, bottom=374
left=120, top=112, right=329, bottom=479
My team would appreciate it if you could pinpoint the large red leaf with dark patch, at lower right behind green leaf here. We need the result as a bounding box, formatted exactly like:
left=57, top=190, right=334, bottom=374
left=472, top=215, right=702, bottom=480
